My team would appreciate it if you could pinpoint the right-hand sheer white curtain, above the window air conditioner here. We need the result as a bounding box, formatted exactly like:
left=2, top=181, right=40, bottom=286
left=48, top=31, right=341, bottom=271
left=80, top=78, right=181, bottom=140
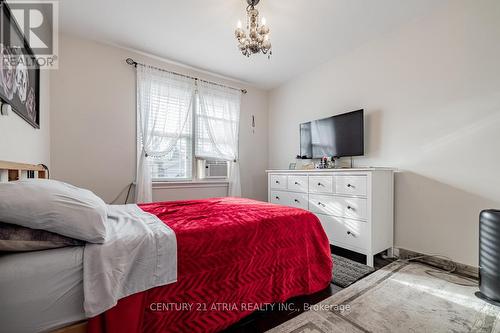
left=195, top=81, right=241, bottom=197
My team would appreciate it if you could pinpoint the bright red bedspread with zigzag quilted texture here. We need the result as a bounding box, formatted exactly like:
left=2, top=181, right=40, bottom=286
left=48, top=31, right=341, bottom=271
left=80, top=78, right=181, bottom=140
left=89, top=198, right=332, bottom=333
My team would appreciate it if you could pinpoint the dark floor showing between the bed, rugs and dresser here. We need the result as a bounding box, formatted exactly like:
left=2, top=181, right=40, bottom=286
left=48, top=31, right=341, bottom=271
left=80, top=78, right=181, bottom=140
left=223, top=246, right=393, bottom=333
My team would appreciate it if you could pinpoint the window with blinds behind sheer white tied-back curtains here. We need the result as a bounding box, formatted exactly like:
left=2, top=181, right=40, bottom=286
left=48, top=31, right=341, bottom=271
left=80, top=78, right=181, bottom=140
left=137, top=67, right=241, bottom=185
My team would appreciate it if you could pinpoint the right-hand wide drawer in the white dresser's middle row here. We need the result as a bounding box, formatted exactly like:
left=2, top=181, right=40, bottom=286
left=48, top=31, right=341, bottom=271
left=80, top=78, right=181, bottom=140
left=309, top=194, right=368, bottom=220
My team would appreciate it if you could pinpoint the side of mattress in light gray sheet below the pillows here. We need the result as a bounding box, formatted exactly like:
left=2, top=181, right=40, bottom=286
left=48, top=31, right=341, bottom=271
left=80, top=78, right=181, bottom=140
left=0, top=246, right=85, bottom=333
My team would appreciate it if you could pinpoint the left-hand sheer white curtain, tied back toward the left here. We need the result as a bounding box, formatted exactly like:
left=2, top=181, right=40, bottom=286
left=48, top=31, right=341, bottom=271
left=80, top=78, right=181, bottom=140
left=135, top=65, right=195, bottom=202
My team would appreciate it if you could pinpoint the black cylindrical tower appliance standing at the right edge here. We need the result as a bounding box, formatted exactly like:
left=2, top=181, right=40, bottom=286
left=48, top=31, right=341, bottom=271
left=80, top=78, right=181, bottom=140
left=476, top=209, right=500, bottom=306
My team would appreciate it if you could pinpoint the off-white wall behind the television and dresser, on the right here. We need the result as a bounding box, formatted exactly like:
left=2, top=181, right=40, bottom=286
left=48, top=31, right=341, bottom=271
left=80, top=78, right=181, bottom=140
left=269, top=0, right=500, bottom=266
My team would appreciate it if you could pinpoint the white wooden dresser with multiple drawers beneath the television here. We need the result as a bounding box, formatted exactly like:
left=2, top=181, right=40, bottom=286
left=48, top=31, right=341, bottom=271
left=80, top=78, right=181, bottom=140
left=267, top=168, right=394, bottom=267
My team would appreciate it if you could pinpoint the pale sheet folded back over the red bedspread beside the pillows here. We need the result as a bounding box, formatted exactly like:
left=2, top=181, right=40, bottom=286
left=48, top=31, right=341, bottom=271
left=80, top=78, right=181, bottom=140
left=83, top=204, right=177, bottom=318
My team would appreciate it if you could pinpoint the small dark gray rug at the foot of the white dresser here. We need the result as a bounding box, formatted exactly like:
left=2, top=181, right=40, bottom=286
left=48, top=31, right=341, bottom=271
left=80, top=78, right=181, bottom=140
left=332, top=254, right=375, bottom=288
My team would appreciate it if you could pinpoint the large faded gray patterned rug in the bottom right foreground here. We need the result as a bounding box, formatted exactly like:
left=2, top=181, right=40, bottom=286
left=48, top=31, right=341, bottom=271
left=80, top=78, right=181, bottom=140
left=269, top=261, right=500, bottom=333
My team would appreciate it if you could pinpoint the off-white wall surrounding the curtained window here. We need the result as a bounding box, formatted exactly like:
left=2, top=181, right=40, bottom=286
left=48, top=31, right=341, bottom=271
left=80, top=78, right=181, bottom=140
left=50, top=35, right=267, bottom=202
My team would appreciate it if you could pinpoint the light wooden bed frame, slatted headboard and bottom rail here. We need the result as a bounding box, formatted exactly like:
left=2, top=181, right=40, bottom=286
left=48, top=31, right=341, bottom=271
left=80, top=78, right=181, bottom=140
left=0, top=161, right=87, bottom=333
